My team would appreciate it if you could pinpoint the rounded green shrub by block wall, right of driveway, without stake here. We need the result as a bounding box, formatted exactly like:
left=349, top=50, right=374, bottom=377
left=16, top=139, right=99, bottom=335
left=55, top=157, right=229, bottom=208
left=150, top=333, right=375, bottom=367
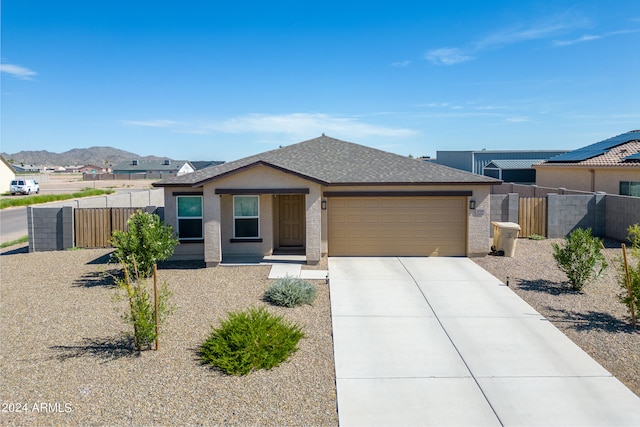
left=552, top=228, right=607, bottom=291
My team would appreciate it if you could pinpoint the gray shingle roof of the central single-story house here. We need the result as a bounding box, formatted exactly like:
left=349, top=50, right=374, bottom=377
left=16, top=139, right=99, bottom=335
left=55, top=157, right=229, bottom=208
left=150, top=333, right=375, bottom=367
left=153, top=134, right=501, bottom=187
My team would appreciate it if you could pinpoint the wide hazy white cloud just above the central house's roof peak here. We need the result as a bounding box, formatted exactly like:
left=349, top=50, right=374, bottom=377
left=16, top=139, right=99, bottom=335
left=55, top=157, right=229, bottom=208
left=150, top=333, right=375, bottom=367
left=202, top=113, right=417, bottom=138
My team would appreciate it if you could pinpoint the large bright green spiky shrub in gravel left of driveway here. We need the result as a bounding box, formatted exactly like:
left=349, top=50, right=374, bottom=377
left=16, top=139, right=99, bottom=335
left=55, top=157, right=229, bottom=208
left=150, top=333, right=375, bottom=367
left=200, top=308, right=304, bottom=375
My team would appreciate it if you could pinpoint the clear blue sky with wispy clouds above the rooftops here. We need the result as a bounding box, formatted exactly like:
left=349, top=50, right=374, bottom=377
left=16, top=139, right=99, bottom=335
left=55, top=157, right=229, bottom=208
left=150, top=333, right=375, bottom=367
left=0, top=0, right=640, bottom=161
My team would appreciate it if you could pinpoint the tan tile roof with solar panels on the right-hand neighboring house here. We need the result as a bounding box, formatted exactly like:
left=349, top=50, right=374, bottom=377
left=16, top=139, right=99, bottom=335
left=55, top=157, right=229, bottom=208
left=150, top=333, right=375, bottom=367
left=536, top=130, right=640, bottom=168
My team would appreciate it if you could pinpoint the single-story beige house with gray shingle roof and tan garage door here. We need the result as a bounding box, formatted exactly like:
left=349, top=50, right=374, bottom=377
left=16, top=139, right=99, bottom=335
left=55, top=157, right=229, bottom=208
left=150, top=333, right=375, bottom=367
left=153, top=135, right=501, bottom=266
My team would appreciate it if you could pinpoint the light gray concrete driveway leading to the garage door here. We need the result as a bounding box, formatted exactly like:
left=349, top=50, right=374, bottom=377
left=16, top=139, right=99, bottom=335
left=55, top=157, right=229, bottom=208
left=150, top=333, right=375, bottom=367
left=329, top=258, right=640, bottom=427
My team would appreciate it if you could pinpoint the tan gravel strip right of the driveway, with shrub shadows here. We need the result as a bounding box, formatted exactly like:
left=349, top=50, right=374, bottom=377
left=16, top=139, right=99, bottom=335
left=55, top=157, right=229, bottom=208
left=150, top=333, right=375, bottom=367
left=472, top=239, right=640, bottom=396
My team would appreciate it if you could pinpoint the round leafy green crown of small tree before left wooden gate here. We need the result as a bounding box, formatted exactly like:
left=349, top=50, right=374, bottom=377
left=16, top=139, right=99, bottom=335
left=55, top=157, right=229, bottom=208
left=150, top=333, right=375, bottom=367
left=111, top=211, right=178, bottom=277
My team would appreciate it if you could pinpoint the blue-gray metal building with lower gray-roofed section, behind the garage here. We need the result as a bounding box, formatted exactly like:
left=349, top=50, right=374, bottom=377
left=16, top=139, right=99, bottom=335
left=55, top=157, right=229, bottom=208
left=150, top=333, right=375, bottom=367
left=432, top=150, right=567, bottom=184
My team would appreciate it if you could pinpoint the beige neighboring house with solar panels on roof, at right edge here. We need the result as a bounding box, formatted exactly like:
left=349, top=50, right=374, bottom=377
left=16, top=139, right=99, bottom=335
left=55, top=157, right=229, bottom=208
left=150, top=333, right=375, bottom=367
left=534, top=130, right=640, bottom=197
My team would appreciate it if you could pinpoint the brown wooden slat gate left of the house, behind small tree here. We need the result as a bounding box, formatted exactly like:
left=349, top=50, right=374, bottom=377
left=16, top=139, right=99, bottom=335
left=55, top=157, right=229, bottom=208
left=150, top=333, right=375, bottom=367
left=74, top=208, right=141, bottom=248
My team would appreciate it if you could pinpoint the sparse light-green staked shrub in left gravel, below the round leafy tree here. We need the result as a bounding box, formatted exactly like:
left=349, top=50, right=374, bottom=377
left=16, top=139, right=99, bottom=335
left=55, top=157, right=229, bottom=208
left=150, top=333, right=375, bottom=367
left=114, top=265, right=174, bottom=351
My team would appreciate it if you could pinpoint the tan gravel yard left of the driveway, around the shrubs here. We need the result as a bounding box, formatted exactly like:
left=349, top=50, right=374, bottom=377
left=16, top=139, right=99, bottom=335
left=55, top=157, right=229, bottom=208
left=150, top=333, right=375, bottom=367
left=0, top=249, right=338, bottom=426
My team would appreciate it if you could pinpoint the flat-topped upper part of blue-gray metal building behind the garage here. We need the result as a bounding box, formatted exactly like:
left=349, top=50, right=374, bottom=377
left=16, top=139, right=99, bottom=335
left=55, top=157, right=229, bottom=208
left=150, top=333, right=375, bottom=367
left=433, top=150, right=567, bottom=176
